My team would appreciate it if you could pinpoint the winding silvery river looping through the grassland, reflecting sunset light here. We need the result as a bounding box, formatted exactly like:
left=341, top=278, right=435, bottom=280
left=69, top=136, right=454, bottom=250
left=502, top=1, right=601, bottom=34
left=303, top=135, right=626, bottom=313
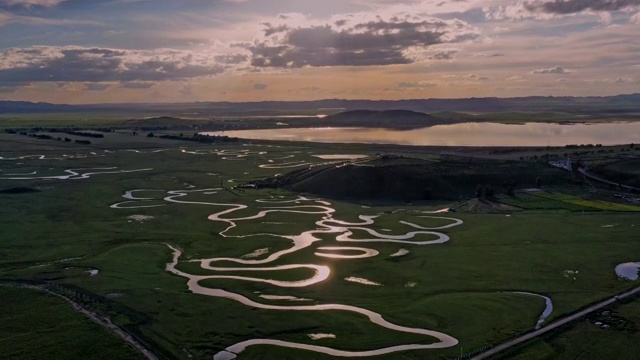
left=115, top=189, right=462, bottom=359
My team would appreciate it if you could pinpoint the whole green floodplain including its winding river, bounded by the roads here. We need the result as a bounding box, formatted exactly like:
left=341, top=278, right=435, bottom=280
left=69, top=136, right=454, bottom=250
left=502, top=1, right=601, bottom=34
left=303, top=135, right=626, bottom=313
left=0, top=134, right=640, bottom=359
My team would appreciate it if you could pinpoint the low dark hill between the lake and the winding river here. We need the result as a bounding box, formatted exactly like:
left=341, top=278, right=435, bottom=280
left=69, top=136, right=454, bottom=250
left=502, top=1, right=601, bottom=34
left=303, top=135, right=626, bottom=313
left=250, top=156, right=571, bottom=201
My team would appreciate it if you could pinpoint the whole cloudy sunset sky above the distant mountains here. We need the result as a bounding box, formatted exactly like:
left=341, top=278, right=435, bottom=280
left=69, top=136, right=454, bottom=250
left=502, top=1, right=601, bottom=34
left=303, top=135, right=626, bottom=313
left=0, top=0, right=640, bottom=104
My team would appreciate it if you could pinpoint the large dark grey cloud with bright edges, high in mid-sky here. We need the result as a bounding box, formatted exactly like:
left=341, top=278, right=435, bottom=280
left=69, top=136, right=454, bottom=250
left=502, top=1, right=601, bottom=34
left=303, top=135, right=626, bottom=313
left=242, top=13, right=479, bottom=68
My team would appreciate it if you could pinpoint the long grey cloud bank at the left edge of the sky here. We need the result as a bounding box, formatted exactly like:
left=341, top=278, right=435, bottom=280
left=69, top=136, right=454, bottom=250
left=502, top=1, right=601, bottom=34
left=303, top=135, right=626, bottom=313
left=0, top=46, right=231, bottom=83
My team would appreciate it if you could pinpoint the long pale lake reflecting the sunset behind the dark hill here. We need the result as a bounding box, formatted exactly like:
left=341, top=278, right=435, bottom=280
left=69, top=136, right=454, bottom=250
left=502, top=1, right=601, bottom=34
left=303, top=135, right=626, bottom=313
left=204, top=122, right=640, bottom=146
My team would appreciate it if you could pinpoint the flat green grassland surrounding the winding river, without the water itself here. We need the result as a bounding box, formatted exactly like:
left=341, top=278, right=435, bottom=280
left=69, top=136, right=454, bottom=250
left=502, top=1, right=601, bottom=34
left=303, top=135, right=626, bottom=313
left=0, top=133, right=640, bottom=359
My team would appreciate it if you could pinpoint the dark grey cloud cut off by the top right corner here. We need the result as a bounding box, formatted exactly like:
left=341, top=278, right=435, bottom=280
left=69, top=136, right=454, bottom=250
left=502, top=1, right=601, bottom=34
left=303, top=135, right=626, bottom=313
left=524, top=0, right=640, bottom=15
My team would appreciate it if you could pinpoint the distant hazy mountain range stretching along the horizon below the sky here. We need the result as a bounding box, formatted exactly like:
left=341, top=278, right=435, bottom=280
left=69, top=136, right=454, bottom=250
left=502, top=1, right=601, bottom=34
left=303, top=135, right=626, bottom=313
left=0, top=94, right=640, bottom=116
